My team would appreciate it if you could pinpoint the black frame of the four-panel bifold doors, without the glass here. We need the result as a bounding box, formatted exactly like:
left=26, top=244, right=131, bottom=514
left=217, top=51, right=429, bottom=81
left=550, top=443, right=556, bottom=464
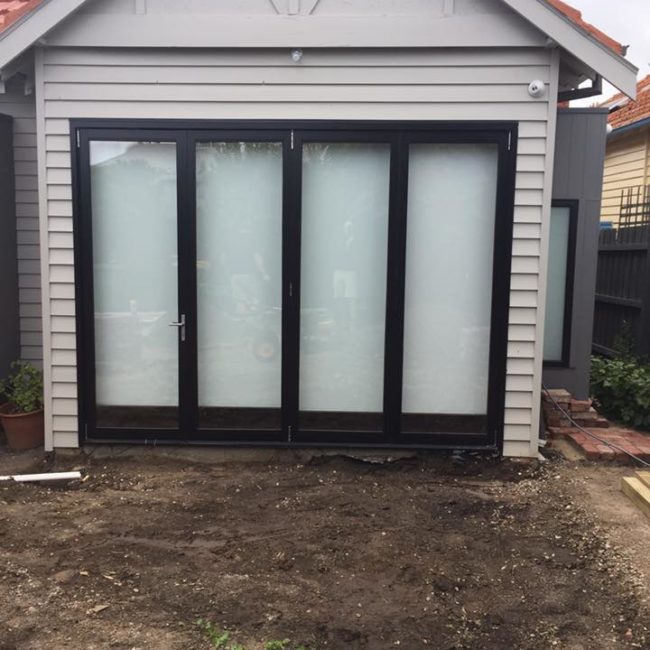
left=70, top=119, right=518, bottom=451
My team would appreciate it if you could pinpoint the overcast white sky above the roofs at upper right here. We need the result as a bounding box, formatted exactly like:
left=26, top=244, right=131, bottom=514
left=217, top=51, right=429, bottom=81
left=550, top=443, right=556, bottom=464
left=567, top=0, right=650, bottom=106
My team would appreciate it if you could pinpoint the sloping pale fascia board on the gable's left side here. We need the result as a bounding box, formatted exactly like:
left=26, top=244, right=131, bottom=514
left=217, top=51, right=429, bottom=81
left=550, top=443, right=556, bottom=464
left=0, top=0, right=86, bottom=68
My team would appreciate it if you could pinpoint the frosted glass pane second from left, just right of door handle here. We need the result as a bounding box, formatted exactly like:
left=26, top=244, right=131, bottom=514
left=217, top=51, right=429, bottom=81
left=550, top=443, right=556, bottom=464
left=196, top=142, right=282, bottom=427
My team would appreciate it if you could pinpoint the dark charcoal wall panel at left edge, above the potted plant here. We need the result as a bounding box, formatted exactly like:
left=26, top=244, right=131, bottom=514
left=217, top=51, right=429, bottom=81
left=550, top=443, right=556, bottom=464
left=0, top=115, right=20, bottom=377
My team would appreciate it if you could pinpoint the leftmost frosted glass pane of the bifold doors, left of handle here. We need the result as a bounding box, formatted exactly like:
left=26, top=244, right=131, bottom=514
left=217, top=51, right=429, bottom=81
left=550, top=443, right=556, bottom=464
left=90, top=141, right=179, bottom=427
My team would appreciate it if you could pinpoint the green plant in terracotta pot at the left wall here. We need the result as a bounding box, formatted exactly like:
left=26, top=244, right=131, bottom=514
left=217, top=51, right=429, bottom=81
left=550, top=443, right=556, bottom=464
left=0, top=361, right=45, bottom=451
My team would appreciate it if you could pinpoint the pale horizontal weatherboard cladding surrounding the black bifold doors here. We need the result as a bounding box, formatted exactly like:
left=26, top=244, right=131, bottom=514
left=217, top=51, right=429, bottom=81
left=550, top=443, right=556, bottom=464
left=41, top=48, right=554, bottom=455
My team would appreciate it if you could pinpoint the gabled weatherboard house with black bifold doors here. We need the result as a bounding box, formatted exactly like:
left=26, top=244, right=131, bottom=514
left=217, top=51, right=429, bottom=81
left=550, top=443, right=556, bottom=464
left=0, top=0, right=637, bottom=457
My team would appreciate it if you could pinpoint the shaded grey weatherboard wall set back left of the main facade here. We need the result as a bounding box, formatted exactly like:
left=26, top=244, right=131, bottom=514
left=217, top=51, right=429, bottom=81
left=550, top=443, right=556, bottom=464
left=0, top=80, right=43, bottom=365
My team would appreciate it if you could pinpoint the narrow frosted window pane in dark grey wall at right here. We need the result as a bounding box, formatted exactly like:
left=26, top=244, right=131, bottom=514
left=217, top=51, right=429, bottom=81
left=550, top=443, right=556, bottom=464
left=544, top=207, right=571, bottom=361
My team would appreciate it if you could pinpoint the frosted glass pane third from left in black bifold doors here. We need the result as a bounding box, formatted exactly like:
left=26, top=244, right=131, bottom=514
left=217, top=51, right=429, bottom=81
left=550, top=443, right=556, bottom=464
left=299, top=144, right=390, bottom=428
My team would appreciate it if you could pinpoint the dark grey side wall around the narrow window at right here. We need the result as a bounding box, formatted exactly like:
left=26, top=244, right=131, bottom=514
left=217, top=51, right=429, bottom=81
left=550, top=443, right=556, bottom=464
left=543, top=109, right=607, bottom=399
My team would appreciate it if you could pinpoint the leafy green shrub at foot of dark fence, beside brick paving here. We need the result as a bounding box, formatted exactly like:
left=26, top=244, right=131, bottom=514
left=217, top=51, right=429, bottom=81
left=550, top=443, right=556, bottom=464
left=591, top=357, right=650, bottom=429
